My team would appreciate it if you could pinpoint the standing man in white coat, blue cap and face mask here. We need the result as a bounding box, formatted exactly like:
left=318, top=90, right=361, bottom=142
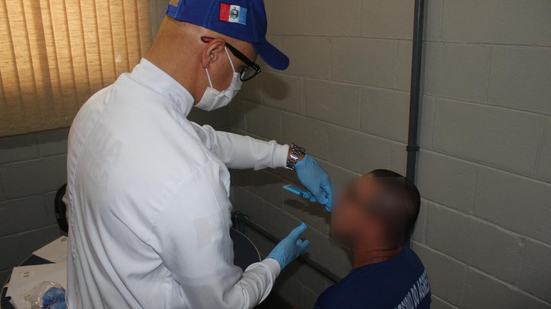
left=65, top=0, right=331, bottom=309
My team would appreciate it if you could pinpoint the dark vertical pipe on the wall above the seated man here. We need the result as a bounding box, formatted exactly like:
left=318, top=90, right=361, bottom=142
left=406, top=0, right=425, bottom=182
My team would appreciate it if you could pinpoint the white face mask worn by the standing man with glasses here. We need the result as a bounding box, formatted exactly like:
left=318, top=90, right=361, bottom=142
left=195, top=47, right=243, bottom=111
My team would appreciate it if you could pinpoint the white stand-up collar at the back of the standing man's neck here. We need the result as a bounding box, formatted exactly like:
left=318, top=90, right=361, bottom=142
left=132, top=58, right=195, bottom=117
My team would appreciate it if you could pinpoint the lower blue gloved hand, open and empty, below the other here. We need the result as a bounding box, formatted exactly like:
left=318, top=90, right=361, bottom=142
left=266, top=223, right=310, bottom=270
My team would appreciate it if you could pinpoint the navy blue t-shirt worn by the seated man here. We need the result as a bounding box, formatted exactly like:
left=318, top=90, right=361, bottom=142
left=315, top=247, right=431, bottom=309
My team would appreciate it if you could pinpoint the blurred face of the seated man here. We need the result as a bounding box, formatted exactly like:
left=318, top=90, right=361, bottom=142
left=331, top=174, right=384, bottom=245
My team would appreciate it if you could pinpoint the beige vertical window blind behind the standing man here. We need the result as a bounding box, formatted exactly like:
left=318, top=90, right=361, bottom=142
left=0, top=0, right=151, bottom=136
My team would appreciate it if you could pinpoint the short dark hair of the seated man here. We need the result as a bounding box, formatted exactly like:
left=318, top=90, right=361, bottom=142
left=369, top=169, right=421, bottom=243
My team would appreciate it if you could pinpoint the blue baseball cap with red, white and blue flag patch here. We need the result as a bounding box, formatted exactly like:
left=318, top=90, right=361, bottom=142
left=166, top=0, right=289, bottom=70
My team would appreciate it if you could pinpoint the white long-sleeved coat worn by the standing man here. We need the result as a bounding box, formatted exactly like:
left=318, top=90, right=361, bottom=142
left=65, top=59, right=289, bottom=309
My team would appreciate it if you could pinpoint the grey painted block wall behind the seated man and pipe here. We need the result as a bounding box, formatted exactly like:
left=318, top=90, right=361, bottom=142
left=230, top=0, right=551, bottom=309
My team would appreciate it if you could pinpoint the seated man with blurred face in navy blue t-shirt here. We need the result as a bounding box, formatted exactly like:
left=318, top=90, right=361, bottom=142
left=315, top=170, right=431, bottom=309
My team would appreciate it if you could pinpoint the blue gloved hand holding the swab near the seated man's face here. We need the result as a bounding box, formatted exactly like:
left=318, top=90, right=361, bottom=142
left=295, top=154, right=333, bottom=212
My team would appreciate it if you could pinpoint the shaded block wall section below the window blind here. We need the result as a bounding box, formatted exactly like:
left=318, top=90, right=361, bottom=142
left=0, top=129, right=69, bottom=284
